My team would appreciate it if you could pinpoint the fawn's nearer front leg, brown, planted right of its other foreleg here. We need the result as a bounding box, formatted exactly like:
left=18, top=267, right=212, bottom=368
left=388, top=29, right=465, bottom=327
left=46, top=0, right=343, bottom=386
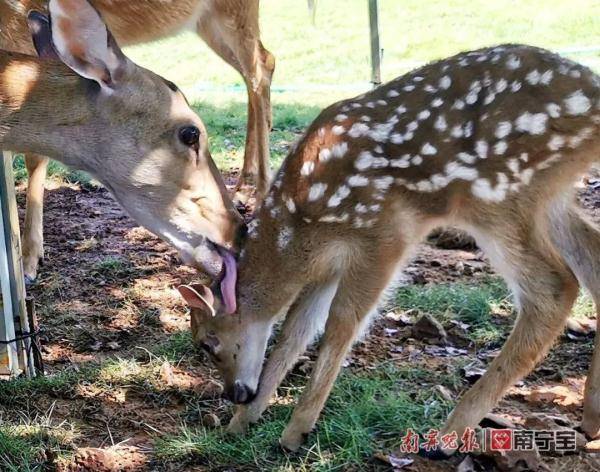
left=280, top=244, right=402, bottom=451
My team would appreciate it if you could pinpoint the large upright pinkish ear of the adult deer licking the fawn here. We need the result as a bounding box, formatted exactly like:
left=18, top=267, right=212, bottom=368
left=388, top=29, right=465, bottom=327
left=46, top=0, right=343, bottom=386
left=48, top=0, right=128, bottom=90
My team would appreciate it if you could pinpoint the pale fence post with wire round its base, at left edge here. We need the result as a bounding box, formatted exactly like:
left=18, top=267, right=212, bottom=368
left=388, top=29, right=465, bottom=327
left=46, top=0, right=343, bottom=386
left=0, top=151, right=34, bottom=377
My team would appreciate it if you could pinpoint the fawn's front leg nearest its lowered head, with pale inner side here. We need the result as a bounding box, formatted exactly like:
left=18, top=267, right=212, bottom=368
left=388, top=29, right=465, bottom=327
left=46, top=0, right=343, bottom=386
left=228, top=279, right=339, bottom=433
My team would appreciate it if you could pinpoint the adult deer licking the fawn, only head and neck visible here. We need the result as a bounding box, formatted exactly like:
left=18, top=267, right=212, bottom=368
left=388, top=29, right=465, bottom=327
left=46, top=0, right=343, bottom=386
left=0, top=0, right=241, bottom=284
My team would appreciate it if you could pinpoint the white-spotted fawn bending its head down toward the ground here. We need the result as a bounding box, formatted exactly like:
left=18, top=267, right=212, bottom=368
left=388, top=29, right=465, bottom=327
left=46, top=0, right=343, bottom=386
left=180, top=45, right=600, bottom=450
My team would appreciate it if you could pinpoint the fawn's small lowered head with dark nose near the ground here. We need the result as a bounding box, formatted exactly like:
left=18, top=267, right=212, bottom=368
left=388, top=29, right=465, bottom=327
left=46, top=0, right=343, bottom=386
left=179, top=283, right=272, bottom=404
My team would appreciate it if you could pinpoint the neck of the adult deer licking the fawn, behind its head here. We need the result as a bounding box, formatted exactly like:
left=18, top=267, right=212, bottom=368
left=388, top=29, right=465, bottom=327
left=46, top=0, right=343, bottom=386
left=0, top=53, right=101, bottom=170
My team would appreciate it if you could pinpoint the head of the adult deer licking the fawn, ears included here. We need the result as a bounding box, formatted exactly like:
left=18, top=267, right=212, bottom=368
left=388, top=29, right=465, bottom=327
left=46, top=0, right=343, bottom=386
left=29, top=0, right=243, bottom=277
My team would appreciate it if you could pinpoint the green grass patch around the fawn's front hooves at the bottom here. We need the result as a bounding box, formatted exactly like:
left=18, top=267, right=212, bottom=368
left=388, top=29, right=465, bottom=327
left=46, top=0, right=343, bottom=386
left=156, top=366, right=450, bottom=471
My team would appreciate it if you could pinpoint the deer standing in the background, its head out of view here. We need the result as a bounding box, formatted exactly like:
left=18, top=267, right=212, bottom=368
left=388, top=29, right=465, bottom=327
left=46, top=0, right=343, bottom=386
left=0, top=0, right=275, bottom=279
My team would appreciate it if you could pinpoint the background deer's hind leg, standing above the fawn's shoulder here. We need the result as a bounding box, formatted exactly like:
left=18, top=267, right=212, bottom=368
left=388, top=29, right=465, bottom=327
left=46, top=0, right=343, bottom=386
left=198, top=0, right=275, bottom=197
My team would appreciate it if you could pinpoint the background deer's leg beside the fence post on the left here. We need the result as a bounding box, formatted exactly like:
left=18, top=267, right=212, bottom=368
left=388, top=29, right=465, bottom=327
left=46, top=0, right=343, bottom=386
left=22, top=154, right=49, bottom=283
